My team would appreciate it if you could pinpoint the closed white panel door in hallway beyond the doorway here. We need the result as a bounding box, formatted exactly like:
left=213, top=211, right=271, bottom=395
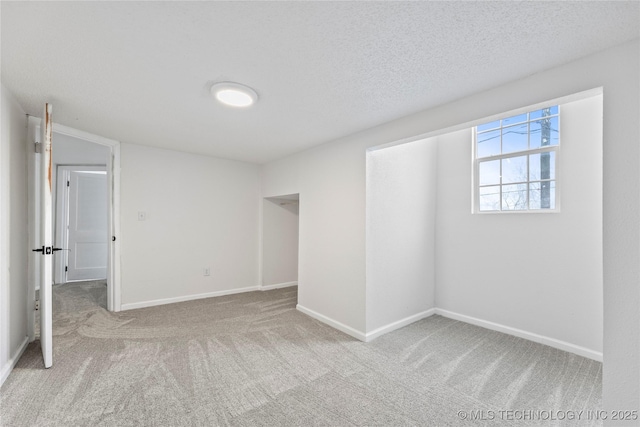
left=67, top=169, right=109, bottom=281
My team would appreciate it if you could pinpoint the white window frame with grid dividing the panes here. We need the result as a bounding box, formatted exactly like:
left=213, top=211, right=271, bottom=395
left=471, top=104, right=562, bottom=215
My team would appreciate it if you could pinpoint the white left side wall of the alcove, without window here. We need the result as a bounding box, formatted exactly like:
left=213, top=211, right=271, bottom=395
left=366, top=138, right=437, bottom=333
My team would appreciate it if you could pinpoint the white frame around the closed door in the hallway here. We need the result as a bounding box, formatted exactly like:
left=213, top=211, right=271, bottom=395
left=53, top=164, right=109, bottom=284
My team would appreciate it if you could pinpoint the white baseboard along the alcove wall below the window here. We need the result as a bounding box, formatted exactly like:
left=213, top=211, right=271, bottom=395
left=435, top=308, right=602, bottom=362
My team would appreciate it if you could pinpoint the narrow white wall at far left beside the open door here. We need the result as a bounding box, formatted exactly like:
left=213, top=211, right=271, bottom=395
left=0, top=86, right=30, bottom=384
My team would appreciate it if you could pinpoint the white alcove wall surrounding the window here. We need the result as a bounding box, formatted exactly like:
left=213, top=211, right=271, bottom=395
left=436, top=96, right=603, bottom=353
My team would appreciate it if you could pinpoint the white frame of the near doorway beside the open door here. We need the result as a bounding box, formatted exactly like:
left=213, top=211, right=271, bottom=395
left=26, top=116, right=121, bottom=341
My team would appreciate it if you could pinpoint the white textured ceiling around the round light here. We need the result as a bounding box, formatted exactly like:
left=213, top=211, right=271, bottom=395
left=0, top=1, right=640, bottom=163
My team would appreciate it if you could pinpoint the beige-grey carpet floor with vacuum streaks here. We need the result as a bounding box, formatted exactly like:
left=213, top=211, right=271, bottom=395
left=0, top=282, right=602, bottom=426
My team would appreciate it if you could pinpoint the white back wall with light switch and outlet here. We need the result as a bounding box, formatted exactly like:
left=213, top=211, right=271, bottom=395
left=121, top=144, right=260, bottom=309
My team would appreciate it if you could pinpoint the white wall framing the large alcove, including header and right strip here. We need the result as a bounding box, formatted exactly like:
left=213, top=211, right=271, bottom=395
left=263, top=40, right=640, bottom=410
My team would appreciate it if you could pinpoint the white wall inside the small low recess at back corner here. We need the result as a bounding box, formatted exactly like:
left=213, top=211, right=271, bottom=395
left=262, top=198, right=298, bottom=286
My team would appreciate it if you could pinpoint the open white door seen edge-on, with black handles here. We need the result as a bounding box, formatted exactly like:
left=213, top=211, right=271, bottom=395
left=34, top=104, right=57, bottom=368
